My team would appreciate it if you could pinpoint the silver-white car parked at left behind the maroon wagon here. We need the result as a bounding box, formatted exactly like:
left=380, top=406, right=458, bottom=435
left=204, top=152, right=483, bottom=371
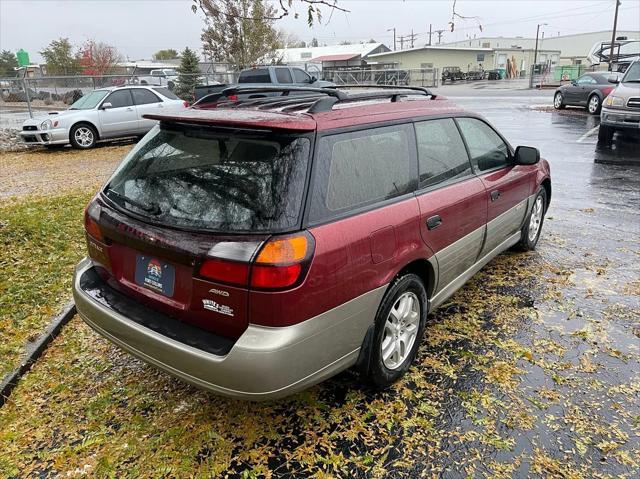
left=20, top=85, right=189, bottom=149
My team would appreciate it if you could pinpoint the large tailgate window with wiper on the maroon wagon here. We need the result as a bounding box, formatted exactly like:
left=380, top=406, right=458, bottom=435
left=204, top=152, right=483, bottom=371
left=103, top=127, right=310, bottom=232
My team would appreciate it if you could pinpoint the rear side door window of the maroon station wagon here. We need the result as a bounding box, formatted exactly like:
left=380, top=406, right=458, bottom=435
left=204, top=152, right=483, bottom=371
left=416, top=118, right=471, bottom=187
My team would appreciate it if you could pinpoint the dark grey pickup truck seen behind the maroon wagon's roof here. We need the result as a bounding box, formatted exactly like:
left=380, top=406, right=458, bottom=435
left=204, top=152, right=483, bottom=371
left=195, top=66, right=335, bottom=101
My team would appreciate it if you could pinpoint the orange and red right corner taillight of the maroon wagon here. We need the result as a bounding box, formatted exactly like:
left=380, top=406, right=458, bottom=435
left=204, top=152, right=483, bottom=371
left=251, top=232, right=315, bottom=289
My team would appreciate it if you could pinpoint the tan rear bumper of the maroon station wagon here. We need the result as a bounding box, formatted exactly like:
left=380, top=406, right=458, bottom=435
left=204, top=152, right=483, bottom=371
left=73, top=258, right=385, bottom=400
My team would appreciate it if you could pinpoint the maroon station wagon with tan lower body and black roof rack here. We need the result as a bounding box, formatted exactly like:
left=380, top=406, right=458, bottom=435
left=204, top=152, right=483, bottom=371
left=74, top=87, right=551, bottom=399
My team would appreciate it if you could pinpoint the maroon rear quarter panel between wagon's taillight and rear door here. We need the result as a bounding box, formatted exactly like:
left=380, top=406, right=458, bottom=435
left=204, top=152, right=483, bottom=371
left=249, top=196, right=431, bottom=326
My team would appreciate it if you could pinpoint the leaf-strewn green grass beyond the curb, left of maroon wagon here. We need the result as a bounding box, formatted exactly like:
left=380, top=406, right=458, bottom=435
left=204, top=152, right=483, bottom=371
left=0, top=191, right=91, bottom=377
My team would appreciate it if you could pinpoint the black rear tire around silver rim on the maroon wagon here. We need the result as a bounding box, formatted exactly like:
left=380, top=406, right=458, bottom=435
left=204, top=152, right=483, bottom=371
left=362, top=274, right=428, bottom=389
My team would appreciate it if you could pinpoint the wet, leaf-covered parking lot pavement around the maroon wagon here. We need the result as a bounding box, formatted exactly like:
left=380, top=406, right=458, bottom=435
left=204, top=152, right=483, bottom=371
left=0, top=93, right=640, bottom=479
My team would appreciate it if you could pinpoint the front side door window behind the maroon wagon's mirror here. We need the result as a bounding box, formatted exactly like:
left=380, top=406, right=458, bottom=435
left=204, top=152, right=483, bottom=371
left=456, top=118, right=509, bottom=171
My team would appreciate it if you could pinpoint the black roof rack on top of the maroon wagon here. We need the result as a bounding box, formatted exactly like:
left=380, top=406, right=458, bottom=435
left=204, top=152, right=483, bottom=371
left=193, top=85, right=436, bottom=113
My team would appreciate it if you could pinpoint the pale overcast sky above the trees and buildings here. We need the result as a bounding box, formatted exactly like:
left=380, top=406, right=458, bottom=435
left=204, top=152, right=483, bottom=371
left=0, top=0, right=640, bottom=61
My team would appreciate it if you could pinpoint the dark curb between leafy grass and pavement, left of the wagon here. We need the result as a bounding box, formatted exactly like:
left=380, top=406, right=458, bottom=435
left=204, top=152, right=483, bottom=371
left=0, top=301, right=76, bottom=407
